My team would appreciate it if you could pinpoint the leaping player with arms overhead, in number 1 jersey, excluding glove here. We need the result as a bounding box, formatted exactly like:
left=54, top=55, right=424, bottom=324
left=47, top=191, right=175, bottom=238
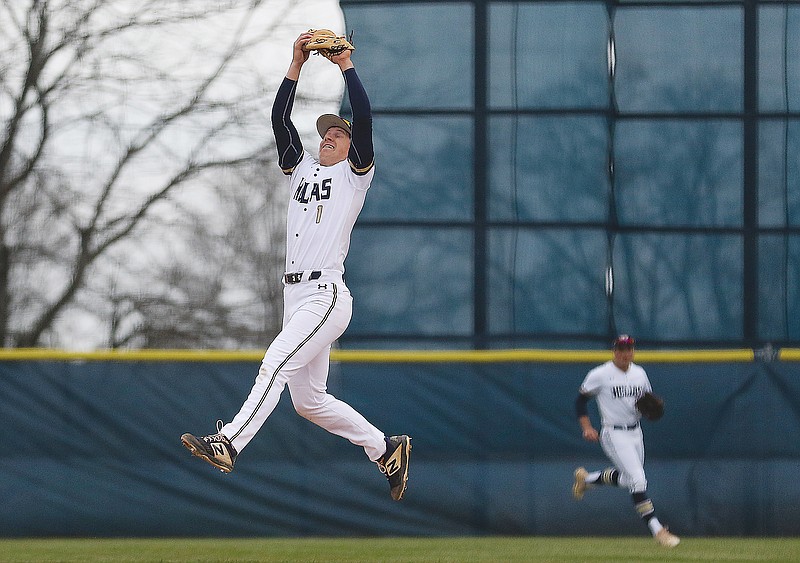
left=181, top=29, right=411, bottom=500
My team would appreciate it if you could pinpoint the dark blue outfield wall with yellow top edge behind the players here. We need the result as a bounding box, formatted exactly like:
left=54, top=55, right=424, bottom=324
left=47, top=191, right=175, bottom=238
left=0, top=350, right=800, bottom=537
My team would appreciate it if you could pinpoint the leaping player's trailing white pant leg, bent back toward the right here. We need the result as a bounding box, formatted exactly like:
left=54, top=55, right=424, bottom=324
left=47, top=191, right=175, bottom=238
left=289, top=346, right=386, bottom=461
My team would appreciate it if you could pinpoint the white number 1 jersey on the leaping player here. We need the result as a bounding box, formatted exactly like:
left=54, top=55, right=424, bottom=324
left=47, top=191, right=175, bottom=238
left=286, top=151, right=375, bottom=273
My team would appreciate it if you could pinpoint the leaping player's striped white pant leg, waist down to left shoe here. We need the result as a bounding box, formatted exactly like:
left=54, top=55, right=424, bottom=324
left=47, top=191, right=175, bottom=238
left=221, top=282, right=353, bottom=452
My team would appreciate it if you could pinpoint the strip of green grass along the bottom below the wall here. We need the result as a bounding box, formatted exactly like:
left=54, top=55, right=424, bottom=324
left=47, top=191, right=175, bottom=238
left=0, top=537, right=800, bottom=563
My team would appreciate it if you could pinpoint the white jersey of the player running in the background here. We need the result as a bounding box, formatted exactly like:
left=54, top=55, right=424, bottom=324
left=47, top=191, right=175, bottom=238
left=580, top=360, right=652, bottom=426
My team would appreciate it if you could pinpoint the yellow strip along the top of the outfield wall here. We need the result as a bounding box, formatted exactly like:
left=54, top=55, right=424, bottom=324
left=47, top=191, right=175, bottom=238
left=0, top=348, right=756, bottom=363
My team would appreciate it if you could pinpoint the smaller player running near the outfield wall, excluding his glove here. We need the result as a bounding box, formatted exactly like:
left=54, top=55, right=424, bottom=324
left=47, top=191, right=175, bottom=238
left=572, top=334, right=680, bottom=547
